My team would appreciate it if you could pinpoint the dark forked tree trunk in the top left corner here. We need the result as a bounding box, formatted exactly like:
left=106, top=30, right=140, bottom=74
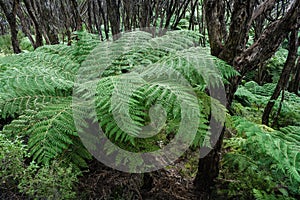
left=0, top=0, right=21, bottom=54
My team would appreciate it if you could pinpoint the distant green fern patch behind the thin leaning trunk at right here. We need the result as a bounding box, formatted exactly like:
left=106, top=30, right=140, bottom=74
left=234, top=81, right=300, bottom=127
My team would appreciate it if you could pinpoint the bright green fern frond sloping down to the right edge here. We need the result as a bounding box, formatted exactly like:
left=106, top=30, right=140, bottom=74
left=235, top=118, right=300, bottom=183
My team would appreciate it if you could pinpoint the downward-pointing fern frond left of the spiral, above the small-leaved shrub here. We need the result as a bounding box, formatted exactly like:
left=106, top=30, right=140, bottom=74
left=28, top=97, right=77, bottom=163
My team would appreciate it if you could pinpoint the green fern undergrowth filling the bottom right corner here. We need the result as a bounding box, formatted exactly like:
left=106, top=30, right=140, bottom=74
left=223, top=117, right=300, bottom=199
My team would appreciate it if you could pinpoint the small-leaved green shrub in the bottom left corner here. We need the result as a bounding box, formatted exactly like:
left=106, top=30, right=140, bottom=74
left=0, top=134, right=80, bottom=199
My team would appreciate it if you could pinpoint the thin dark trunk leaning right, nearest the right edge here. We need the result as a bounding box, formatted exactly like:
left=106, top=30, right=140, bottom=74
left=262, top=29, right=299, bottom=126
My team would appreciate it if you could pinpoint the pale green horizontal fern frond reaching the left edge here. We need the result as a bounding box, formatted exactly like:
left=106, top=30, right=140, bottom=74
left=0, top=67, right=73, bottom=118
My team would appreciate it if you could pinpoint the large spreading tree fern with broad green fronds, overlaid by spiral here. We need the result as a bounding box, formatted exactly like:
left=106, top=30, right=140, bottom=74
left=0, top=31, right=236, bottom=170
